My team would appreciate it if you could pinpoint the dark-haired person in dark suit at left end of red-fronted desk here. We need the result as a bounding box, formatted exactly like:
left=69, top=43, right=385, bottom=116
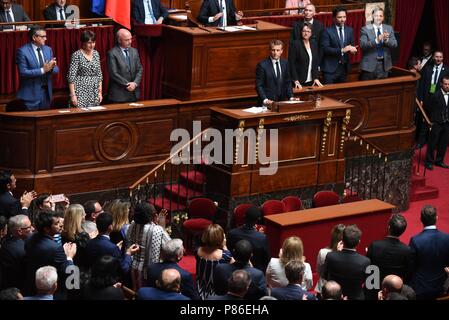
left=227, top=206, right=270, bottom=272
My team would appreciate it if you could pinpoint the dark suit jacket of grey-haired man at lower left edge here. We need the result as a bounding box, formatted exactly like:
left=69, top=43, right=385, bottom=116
left=0, top=236, right=26, bottom=290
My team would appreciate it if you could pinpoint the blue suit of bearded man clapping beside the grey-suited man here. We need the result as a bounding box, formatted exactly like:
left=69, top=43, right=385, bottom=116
left=321, top=24, right=354, bottom=83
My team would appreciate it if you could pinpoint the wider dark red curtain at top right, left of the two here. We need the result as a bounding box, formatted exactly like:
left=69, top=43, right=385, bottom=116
left=394, top=0, right=426, bottom=68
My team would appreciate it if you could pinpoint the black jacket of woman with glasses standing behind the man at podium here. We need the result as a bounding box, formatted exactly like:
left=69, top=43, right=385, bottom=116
left=288, top=40, right=320, bottom=85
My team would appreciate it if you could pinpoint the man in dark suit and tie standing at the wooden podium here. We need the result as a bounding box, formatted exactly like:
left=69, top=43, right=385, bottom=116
left=256, top=40, right=293, bottom=106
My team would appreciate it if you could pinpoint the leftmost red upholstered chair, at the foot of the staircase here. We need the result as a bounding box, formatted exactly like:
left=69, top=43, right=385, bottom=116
left=183, top=198, right=217, bottom=249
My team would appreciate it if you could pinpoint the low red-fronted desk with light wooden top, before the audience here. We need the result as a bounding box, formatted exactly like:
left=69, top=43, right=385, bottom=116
left=265, top=199, right=395, bottom=272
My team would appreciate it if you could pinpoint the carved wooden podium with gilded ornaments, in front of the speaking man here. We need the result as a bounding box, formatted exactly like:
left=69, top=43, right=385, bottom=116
left=207, top=97, right=352, bottom=206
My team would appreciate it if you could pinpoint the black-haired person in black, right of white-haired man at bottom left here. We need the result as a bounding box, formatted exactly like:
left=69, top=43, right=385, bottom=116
left=83, top=255, right=125, bottom=300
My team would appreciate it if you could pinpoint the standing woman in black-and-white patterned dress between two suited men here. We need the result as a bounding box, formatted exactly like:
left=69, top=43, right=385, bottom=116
left=67, top=31, right=103, bottom=108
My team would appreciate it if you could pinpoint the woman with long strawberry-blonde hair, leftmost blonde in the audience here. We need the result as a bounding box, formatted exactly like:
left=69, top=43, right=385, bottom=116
left=61, top=204, right=90, bottom=270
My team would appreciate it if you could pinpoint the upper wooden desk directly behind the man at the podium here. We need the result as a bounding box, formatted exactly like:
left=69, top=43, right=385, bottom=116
left=163, top=22, right=291, bottom=100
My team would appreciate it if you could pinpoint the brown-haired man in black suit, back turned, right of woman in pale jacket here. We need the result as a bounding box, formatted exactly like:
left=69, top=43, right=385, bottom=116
left=323, top=225, right=371, bottom=300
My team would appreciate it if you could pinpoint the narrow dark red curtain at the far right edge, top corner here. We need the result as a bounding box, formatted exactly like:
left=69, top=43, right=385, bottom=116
left=433, top=0, right=449, bottom=62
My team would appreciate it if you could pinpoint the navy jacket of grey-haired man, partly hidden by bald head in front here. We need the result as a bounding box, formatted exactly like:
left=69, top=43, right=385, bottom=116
left=146, top=262, right=201, bottom=300
